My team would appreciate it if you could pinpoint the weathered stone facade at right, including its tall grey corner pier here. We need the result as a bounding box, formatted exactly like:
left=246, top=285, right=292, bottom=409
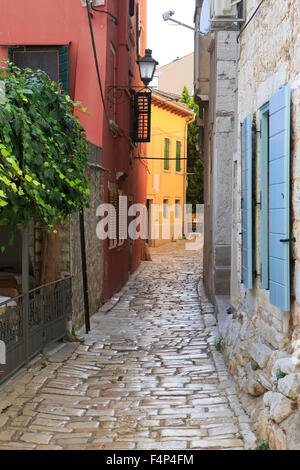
left=196, top=0, right=300, bottom=450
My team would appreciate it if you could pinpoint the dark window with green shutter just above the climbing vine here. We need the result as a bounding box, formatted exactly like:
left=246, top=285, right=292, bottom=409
left=8, top=45, right=69, bottom=93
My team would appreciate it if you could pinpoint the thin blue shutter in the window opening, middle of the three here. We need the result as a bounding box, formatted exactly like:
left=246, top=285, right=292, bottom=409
left=260, top=105, right=269, bottom=289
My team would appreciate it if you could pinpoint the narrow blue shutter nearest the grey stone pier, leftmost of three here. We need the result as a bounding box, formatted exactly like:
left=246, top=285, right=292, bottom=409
left=242, top=114, right=252, bottom=289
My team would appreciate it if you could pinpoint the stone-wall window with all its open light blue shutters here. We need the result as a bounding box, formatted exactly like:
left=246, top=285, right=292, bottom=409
left=242, top=85, right=293, bottom=311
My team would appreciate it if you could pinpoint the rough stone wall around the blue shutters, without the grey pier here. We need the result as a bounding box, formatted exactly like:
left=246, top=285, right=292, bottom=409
left=219, top=0, right=300, bottom=450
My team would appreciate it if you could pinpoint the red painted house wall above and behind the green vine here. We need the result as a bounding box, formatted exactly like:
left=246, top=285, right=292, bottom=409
left=0, top=0, right=146, bottom=300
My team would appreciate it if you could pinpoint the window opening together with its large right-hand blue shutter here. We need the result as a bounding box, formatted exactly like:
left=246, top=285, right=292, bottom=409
left=260, top=84, right=293, bottom=311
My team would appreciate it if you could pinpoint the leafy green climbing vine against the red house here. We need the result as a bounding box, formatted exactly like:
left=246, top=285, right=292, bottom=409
left=0, top=64, right=90, bottom=233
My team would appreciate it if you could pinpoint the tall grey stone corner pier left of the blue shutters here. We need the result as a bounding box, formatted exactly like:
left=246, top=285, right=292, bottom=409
left=204, top=32, right=236, bottom=300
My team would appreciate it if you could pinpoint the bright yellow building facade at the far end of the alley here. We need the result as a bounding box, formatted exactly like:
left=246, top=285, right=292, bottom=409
left=147, top=90, right=195, bottom=247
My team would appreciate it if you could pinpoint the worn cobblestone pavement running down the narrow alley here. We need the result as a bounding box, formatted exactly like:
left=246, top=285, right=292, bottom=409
left=0, top=241, right=256, bottom=450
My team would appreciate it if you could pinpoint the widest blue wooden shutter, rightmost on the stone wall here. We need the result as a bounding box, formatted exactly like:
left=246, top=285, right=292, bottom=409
left=269, top=85, right=291, bottom=311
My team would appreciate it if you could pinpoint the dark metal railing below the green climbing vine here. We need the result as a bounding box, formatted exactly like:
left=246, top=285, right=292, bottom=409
left=0, top=276, right=72, bottom=383
